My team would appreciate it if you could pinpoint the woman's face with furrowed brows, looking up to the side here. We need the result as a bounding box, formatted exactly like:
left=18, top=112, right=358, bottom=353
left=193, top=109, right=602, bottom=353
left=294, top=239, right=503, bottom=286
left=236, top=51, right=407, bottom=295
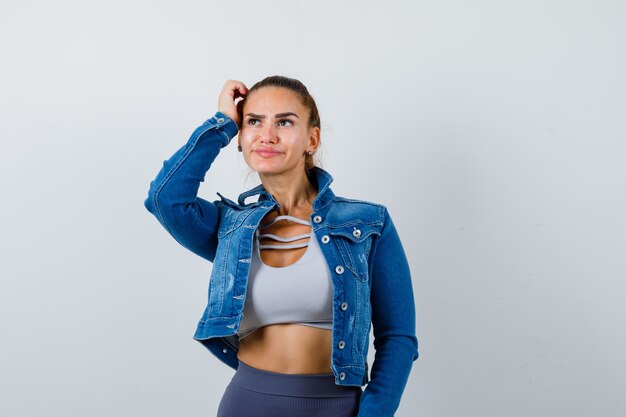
left=239, top=87, right=319, bottom=174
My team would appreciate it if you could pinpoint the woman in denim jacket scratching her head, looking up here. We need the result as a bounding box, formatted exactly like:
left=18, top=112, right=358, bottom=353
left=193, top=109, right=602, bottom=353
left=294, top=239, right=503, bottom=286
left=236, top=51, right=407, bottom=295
left=145, top=76, right=418, bottom=417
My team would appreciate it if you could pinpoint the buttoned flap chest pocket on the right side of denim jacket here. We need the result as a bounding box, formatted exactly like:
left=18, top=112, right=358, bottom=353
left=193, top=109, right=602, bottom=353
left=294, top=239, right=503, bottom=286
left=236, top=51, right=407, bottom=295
left=328, top=222, right=382, bottom=281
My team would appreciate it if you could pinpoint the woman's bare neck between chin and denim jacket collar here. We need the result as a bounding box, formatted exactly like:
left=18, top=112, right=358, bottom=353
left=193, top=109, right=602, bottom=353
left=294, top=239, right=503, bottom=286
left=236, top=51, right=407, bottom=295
left=259, top=165, right=317, bottom=217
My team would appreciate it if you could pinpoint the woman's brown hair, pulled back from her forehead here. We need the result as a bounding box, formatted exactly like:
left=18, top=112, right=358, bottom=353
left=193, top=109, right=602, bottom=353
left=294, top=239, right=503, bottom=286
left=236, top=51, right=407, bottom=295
left=237, top=75, right=321, bottom=174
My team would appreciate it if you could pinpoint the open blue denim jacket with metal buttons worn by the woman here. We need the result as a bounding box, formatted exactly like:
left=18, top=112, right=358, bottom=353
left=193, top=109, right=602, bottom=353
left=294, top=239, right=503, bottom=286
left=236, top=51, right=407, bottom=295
left=144, top=111, right=418, bottom=417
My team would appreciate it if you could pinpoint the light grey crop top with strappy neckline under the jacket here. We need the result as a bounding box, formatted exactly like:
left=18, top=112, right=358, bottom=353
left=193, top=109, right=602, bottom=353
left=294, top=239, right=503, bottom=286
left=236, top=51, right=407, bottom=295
left=237, top=215, right=333, bottom=339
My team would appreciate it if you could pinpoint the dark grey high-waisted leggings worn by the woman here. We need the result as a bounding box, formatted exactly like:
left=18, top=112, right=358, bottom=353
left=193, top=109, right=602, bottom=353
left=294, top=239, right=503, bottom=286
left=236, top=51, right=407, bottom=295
left=217, top=360, right=363, bottom=417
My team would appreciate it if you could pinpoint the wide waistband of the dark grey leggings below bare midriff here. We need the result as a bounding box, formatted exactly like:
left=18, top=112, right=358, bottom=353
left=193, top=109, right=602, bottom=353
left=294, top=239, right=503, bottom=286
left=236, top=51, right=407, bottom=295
left=232, top=360, right=362, bottom=397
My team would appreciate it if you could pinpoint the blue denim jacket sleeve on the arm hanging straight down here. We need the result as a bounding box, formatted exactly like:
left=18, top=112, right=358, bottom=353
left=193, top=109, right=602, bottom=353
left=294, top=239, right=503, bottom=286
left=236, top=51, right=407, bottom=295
left=358, top=207, right=419, bottom=417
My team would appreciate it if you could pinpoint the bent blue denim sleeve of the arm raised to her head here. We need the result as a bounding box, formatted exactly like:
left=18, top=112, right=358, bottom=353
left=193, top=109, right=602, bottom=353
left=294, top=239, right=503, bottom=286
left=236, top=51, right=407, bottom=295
left=144, top=111, right=239, bottom=262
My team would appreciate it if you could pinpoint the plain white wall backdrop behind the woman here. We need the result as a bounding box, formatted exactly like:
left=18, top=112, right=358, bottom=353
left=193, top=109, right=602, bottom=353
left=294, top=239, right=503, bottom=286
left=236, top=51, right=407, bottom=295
left=0, top=0, right=626, bottom=417
